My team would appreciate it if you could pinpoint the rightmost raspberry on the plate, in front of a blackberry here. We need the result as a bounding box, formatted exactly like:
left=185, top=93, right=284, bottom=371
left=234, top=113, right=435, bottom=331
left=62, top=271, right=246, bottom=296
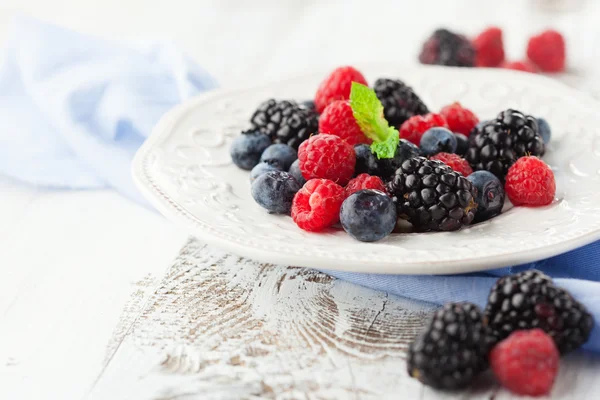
left=504, top=156, right=556, bottom=207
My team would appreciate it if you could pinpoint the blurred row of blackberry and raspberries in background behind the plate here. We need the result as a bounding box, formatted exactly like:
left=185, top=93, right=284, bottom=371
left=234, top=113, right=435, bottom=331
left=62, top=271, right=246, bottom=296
left=419, top=26, right=566, bottom=73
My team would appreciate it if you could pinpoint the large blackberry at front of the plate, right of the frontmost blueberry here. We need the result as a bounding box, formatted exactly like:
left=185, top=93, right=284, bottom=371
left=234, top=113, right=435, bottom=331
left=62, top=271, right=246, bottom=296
left=386, top=157, right=477, bottom=231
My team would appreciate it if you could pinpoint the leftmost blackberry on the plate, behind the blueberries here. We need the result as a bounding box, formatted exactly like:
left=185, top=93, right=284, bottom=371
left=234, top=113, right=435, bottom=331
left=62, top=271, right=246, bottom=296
left=250, top=99, right=319, bottom=150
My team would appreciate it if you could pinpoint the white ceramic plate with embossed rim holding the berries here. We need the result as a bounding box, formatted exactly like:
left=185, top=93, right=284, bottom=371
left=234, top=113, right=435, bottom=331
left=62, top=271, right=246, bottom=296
left=133, top=66, right=600, bottom=274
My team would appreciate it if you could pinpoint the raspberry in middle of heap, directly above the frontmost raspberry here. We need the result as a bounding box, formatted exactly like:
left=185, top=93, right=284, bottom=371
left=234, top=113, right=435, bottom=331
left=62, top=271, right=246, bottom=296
left=298, top=134, right=356, bottom=185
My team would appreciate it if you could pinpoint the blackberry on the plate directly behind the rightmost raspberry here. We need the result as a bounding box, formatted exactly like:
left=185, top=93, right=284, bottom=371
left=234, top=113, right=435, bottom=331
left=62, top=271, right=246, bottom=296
left=465, top=109, right=545, bottom=181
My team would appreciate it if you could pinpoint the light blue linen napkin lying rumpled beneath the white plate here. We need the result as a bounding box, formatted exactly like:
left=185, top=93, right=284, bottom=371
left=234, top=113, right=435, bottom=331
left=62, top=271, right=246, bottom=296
left=0, top=18, right=600, bottom=352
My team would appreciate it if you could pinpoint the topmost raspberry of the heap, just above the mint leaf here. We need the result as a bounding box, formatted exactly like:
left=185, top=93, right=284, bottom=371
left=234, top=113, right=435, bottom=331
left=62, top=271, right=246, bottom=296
left=315, top=67, right=367, bottom=114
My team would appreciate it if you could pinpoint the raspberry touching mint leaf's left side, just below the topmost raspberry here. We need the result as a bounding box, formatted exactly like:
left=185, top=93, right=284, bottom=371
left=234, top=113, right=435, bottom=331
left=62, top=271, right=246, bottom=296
left=319, top=100, right=371, bottom=146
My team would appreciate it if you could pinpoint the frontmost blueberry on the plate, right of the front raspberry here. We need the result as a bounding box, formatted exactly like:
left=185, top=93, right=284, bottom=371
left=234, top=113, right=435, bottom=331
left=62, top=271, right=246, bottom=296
left=340, top=189, right=397, bottom=242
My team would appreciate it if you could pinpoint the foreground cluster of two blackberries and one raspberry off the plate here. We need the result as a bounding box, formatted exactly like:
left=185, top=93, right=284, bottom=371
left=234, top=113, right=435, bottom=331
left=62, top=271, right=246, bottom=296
left=407, top=270, right=594, bottom=396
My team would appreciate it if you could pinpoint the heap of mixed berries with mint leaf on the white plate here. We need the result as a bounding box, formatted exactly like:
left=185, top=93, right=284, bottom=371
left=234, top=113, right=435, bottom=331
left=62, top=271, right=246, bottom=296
left=231, top=65, right=556, bottom=242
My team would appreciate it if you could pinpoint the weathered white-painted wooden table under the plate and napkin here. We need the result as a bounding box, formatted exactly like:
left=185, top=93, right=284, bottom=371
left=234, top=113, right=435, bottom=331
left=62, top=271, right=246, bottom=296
left=0, top=0, right=600, bottom=400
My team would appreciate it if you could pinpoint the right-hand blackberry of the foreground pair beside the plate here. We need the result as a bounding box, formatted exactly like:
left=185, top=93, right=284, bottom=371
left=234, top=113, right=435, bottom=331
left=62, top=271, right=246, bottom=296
left=485, top=270, right=594, bottom=354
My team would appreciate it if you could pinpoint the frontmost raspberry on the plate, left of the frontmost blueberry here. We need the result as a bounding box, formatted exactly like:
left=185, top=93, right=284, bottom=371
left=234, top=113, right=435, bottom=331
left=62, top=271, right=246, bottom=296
left=292, top=179, right=344, bottom=232
